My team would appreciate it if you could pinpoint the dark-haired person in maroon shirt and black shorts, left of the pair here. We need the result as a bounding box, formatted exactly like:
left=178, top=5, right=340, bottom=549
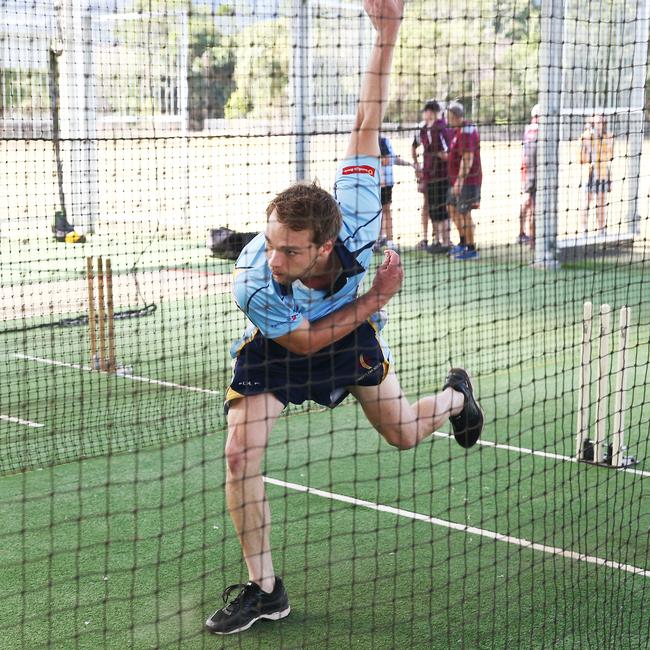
left=411, top=99, right=451, bottom=253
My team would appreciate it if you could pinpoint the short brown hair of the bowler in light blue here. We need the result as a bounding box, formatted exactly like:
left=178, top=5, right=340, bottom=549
left=266, top=183, right=342, bottom=246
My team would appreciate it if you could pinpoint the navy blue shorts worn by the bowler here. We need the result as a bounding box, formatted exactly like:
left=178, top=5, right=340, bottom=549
left=226, top=322, right=389, bottom=410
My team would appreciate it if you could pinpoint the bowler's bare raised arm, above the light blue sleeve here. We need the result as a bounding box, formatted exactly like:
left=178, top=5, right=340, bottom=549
left=345, top=0, right=404, bottom=158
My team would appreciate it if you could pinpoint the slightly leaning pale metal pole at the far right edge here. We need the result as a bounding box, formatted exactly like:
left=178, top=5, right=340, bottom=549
left=626, top=0, right=650, bottom=235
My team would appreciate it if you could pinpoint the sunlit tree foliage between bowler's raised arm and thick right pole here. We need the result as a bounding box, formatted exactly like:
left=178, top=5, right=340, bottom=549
left=388, top=0, right=540, bottom=123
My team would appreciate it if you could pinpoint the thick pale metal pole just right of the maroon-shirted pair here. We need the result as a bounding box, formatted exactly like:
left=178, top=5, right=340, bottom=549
left=533, top=0, right=564, bottom=269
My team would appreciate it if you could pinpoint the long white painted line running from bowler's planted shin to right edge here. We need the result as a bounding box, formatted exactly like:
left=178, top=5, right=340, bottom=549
left=264, top=476, right=650, bottom=578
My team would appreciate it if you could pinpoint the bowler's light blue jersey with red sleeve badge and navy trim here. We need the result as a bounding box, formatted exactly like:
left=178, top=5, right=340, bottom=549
left=232, top=156, right=381, bottom=344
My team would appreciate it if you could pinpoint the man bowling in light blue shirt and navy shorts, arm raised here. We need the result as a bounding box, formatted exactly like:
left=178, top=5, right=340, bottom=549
left=206, top=0, right=483, bottom=634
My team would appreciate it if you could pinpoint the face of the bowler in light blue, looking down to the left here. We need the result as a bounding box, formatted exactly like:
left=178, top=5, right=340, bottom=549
left=265, top=211, right=332, bottom=284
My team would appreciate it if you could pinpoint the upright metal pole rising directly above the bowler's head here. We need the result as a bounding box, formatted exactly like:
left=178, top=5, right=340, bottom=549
left=291, top=0, right=309, bottom=181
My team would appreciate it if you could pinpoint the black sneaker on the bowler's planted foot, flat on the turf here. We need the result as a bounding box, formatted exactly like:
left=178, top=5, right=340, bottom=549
left=205, top=577, right=291, bottom=634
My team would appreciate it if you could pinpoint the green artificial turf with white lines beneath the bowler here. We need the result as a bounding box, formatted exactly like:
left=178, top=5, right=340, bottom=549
left=0, top=244, right=650, bottom=649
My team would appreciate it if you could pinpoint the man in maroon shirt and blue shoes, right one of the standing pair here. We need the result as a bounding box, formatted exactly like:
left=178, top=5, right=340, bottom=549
left=447, top=102, right=483, bottom=260
